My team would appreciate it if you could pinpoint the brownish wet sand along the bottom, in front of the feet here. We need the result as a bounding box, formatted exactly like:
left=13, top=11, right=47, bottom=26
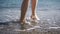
left=0, top=23, right=60, bottom=34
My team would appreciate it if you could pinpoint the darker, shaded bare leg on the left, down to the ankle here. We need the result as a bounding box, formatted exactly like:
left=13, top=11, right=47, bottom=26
left=20, top=0, right=29, bottom=24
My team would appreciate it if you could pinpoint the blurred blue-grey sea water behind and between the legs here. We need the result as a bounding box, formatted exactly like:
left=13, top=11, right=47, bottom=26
left=0, top=0, right=60, bottom=26
